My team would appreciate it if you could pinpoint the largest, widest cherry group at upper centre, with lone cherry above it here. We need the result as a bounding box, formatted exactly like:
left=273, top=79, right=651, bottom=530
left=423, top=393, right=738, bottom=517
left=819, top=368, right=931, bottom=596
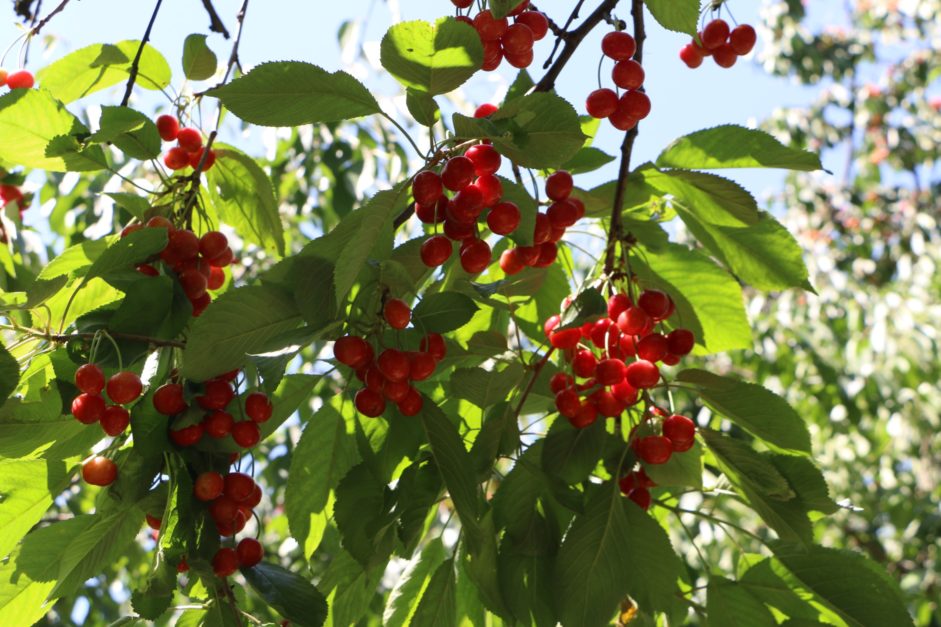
left=412, top=142, right=585, bottom=274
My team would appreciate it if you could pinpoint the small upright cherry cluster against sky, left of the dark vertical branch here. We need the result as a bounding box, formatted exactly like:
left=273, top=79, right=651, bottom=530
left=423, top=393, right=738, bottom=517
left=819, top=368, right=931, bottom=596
left=585, top=31, right=651, bottom=131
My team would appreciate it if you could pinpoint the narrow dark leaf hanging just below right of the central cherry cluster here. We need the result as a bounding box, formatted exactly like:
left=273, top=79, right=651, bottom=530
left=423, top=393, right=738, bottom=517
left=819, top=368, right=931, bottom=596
left=419, top=397, right=480, bottom=545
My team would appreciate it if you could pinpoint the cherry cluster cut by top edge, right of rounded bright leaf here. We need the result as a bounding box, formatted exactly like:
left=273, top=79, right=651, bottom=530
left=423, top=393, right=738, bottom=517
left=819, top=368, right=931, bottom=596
left=451, top=0, right=549, bottom=72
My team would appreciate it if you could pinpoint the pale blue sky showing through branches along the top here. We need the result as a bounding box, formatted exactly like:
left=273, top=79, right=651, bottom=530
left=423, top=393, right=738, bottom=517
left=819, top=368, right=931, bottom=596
left=0, top=0, right=813, bottom=199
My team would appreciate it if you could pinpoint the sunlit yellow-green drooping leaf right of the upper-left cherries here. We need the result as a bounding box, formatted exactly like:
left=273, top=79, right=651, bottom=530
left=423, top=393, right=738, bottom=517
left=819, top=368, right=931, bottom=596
left=206, top=144, right=284, bottom=255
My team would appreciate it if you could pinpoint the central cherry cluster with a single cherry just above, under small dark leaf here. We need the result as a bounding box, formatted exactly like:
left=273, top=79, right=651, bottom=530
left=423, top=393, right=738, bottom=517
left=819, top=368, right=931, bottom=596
left=333, top=298, right=446, bottom=418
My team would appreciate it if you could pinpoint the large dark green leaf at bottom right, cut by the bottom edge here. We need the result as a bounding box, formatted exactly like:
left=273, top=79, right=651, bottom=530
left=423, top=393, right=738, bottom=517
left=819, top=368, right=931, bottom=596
left=772, top=543, right=913, bottom=627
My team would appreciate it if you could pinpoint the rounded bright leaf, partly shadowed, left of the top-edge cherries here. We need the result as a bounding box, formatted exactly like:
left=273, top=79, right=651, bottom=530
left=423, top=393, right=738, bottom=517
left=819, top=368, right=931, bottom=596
left=380, top=17, right=484, bottom=96
